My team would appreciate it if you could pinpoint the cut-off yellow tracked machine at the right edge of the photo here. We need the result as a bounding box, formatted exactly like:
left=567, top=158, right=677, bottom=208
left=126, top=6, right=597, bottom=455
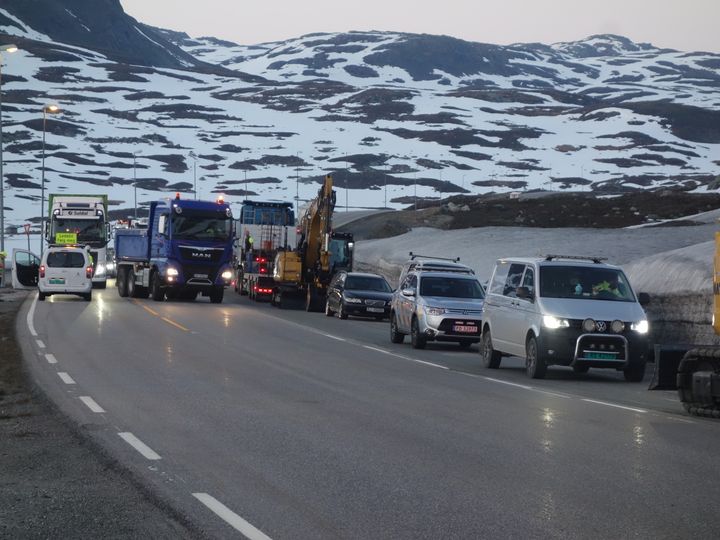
left=677, top=232, right=720, bottom=418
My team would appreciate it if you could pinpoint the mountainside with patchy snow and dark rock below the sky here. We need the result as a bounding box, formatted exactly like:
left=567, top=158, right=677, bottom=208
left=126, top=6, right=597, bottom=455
left=0, top=0, right=720, bottom=236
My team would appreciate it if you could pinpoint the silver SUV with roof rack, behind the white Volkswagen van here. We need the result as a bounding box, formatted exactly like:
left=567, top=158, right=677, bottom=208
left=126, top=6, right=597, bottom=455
left=390, top=263, right=485, bottom=349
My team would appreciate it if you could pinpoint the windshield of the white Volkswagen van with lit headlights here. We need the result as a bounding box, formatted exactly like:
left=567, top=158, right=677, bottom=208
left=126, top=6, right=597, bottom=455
left=540, top=266, right=635, bottom=302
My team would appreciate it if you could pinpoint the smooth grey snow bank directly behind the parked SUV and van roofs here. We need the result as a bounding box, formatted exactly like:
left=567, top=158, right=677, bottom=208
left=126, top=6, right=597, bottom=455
left=355, top=224, right=716, bottom=293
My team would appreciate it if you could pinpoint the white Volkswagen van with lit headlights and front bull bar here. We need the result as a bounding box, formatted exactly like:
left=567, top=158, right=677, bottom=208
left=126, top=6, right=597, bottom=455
left=480, top=255, right=650, bottom=382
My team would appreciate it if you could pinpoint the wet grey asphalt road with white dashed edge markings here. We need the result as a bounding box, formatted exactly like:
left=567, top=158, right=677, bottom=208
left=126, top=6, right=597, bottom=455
left=18, top=288, right=720, bottom=539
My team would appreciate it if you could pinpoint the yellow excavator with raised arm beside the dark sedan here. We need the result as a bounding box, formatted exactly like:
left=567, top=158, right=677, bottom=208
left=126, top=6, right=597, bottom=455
left=272, top=175, right=354, bottom=311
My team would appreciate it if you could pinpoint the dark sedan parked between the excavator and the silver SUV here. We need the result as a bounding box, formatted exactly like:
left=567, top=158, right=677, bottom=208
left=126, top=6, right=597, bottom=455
left=325, top=272, right=392, bottom=320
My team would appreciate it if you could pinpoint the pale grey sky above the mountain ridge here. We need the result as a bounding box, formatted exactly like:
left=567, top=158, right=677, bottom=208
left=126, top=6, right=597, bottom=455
left=121, top=0, right=720, bottom=53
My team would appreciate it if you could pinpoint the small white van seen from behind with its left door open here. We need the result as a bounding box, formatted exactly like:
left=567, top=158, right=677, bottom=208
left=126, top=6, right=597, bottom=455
left=12, top=246, right=93, bottom=301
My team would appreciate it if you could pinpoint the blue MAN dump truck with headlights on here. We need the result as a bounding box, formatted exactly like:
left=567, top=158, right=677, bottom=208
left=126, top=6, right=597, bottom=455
left=115, top=194, right=234, bottom=304
